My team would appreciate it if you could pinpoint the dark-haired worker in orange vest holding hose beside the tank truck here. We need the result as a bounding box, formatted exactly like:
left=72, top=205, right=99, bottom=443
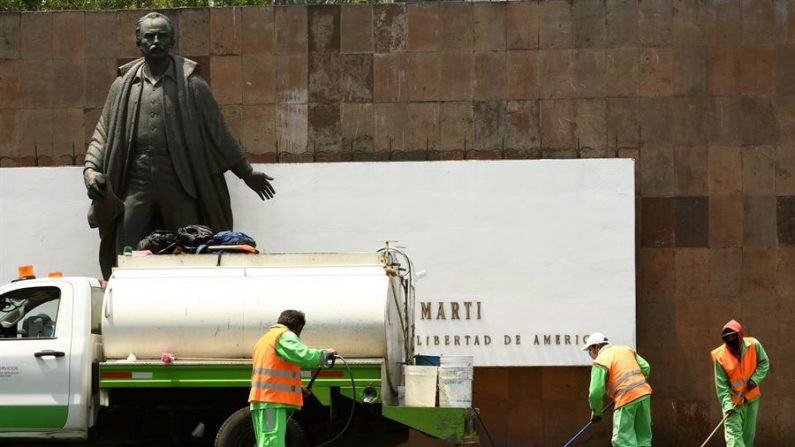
left=248, top=310, right=337, bottom=447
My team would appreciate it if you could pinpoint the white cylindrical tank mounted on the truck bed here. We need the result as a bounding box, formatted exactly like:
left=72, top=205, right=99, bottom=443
left=102, top=255, right=400, bottom=360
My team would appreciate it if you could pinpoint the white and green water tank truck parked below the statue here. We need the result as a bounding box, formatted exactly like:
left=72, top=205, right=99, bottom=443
left=0, top=248, right=479, bottom=447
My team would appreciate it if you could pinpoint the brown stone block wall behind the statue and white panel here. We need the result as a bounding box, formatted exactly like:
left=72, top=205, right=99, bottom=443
left=0, top=0, right=795, bottom=446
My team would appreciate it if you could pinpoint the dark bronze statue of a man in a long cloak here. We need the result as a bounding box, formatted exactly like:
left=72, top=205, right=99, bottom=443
left=83, top=12, right=274, bottom=278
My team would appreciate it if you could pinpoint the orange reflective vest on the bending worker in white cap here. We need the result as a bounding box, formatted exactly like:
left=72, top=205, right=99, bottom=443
left=594, top=345, right=651, bottom=408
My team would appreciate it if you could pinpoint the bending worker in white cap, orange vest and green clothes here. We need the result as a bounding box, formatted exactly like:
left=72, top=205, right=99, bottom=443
left=582, top=332, right=651, bottom=447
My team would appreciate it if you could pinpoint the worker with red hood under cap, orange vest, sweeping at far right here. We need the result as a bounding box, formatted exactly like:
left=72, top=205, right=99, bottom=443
left=712, top=320, right=770, bottom=447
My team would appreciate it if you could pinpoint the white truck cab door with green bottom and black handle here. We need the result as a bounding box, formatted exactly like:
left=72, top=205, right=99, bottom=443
left=0, top=281, right=73, bottom=432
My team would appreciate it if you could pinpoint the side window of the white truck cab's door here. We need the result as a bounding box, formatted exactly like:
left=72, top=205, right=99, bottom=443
left=0, top=286, right=61, bottom=340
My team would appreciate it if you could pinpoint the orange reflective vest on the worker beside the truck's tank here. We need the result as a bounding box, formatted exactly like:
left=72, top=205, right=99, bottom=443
left=248, top=324, right=304, bottom=407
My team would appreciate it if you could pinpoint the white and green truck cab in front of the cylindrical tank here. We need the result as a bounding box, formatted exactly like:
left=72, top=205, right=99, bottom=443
left=0, top=277, right=103, bottom=439
